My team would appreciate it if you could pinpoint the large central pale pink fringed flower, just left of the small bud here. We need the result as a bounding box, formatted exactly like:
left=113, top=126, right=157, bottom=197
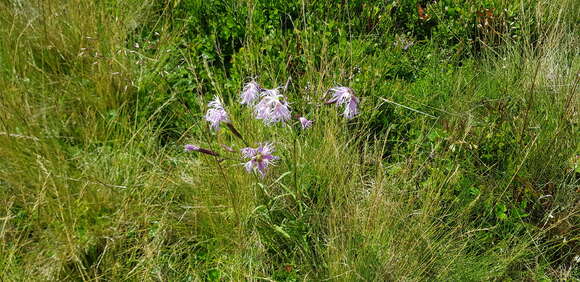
left=254, top=89, right=291, bottom=125
